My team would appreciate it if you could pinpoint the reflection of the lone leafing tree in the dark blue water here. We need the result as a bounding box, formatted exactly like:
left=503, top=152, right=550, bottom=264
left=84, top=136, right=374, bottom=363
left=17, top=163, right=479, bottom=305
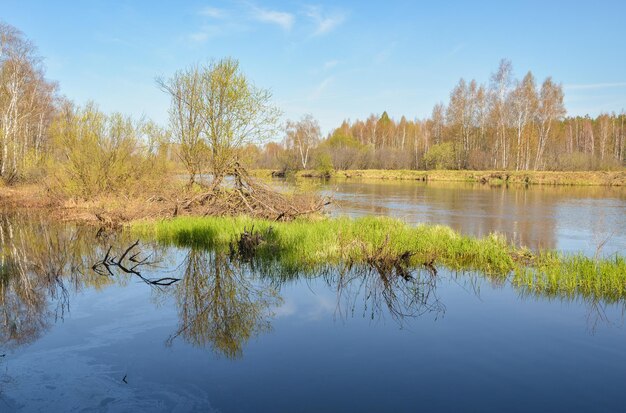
left=167, top=249, right=281, bottom=358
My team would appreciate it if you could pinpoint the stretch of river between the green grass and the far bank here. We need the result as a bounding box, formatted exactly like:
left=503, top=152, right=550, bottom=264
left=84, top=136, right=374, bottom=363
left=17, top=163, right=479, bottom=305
left=316, top=181, right=626, bottom=255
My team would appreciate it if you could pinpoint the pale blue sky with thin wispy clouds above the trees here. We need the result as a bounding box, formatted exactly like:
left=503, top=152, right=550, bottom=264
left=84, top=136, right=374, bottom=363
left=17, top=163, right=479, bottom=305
left=0, top=0, right=626, bottom=134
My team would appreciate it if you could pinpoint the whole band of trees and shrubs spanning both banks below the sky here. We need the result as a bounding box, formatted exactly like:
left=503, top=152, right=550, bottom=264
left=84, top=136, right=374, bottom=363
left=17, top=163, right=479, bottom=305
left=0, top=24, right=626, bottom=197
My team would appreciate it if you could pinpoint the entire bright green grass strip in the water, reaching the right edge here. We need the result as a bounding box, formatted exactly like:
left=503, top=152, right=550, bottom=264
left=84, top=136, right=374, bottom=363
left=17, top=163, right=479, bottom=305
left=130, top=216, right=626, bottom=301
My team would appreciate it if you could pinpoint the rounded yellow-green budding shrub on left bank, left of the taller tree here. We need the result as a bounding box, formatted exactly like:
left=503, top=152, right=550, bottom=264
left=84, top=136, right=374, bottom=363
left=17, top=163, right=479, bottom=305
left=47, top=104, right=167, bottom=199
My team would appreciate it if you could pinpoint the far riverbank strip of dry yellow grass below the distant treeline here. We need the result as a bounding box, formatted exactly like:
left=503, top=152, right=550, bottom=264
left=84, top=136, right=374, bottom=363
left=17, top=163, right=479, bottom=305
left=251, top=169, right=626, bottom=186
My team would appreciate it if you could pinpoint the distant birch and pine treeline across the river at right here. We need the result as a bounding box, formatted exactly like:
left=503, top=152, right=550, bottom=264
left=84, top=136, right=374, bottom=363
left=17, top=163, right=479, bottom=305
left=250, top=60, right=626, bottom=170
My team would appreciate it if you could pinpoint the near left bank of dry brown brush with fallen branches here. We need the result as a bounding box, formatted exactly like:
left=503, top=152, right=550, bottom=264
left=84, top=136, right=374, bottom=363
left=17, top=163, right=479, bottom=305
left=0, top=179, right=330, bottom=228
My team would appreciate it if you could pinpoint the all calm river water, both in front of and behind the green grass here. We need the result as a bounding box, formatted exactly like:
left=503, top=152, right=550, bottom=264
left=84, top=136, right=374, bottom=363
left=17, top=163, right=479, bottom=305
left=0, top=183, right=626, bottom=412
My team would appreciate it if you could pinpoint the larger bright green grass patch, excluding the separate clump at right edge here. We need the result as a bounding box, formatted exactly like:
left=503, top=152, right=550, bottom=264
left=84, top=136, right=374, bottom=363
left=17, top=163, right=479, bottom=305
left=132, top=217, right=515, bottom=275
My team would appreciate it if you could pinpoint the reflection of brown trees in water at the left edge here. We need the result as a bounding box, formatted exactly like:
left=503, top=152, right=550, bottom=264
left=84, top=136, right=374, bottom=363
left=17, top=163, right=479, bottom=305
left=0, top=213, right=129, bottom=347
